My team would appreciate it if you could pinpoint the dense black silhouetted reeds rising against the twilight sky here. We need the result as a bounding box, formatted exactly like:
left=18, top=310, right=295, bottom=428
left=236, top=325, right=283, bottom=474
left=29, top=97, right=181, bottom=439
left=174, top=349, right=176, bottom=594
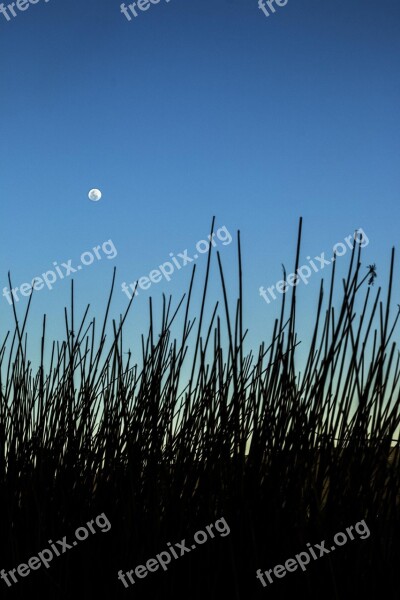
left=0, top=222, right=400, bottom=600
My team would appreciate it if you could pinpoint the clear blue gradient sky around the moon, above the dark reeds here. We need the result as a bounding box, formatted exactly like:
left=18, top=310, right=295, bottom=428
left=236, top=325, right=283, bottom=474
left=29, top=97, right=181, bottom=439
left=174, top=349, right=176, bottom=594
left=0, top=0, right=400, bottom=364
